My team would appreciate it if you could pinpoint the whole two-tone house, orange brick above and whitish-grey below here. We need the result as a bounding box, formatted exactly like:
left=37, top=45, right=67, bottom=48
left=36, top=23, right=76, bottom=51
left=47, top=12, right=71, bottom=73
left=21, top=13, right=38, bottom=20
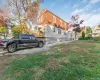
left=35, top=9, right=68, bottom=38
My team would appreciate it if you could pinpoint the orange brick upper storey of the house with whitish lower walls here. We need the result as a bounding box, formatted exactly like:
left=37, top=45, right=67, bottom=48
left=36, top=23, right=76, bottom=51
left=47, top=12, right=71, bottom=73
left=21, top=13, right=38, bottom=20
left=38, top=9, right=68, bottom=30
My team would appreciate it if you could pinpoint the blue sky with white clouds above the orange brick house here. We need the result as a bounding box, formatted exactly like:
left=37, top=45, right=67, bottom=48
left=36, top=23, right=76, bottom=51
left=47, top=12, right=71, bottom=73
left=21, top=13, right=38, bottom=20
left=40, top=0, right=100, bottom=27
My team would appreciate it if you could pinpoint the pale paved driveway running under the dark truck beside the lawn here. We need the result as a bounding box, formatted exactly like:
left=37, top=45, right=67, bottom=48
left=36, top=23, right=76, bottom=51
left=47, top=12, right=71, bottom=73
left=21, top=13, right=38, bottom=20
left=0, top=41, right=71, bottom=56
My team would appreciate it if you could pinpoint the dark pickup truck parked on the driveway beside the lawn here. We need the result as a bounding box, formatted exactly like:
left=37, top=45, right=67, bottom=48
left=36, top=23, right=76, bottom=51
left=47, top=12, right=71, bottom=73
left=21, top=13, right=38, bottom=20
left=4, top=34, right=44, bottom=53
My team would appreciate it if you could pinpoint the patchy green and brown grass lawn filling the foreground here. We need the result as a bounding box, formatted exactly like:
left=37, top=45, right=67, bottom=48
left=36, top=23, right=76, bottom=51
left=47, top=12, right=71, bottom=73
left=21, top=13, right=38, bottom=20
left=0, top=41, right=100, bottom=80
